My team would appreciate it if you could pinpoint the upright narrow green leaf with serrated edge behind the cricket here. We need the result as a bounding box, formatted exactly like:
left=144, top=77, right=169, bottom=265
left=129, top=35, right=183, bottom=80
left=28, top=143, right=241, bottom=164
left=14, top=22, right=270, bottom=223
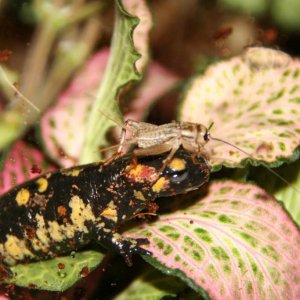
left=80, top=0, right=150, bottom=163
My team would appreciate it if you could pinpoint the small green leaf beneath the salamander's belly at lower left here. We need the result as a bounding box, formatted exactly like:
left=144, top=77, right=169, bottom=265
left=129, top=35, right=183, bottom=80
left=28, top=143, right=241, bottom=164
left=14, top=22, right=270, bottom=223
left=7, top=251, right=104, bottom=292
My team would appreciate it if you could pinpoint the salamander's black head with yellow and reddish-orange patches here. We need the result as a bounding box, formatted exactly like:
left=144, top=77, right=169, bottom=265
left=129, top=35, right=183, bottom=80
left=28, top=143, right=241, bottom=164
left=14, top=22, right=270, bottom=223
left=125, top=148, right=210, bottom=198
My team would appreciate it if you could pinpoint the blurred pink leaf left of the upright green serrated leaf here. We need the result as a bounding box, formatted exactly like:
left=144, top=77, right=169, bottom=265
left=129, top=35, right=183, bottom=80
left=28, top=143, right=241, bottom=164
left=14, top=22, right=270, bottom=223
left=40, top=48, right=109, bottom=167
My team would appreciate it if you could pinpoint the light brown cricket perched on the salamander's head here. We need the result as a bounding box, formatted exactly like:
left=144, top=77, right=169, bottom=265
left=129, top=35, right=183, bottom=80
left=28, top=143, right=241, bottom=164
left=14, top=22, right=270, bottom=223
left=106, top=119, right=210, bottom=172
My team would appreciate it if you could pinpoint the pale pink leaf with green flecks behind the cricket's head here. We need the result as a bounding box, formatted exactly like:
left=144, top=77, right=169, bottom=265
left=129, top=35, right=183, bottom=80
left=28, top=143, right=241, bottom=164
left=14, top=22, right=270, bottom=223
left=180, top=47, right=300, bottom=169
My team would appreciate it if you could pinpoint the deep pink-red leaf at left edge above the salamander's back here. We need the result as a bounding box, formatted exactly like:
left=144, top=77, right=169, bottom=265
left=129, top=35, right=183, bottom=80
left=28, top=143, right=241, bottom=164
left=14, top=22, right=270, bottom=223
left=0, top=141, right=55, bottom=194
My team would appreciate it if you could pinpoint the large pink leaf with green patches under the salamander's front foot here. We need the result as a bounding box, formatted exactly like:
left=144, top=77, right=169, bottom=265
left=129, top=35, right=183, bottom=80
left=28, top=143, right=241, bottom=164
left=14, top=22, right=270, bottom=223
left=126, top=181, right=300, bottom=299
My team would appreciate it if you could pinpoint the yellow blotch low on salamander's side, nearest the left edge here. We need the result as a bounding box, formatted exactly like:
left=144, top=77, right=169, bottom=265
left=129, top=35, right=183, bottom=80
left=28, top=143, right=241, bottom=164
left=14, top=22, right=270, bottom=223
left=4, top=234, right=33, bottom=261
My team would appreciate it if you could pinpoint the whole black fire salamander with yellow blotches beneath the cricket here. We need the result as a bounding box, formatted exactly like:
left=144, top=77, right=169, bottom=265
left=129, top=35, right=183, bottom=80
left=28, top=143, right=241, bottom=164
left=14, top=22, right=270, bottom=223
left=0, top=149, right=209, bottom=279
